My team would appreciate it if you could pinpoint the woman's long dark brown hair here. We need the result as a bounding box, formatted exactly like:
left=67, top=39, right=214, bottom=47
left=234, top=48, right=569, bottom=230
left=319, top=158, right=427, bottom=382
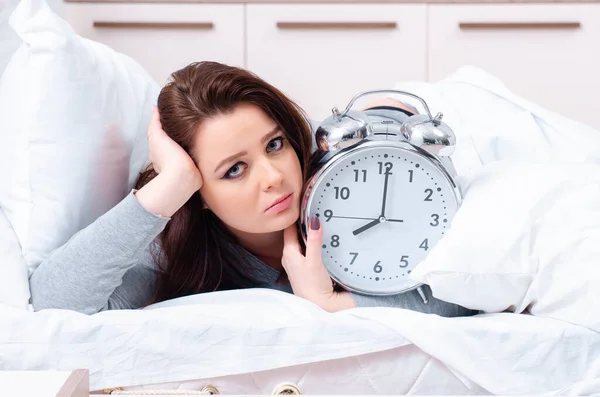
left=135, top=62, right=312, bottom=303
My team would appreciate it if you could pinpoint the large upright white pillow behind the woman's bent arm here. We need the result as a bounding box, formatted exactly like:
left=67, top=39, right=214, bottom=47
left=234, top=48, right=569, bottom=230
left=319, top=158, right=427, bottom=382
left=0, top=0, right=159, bottom=275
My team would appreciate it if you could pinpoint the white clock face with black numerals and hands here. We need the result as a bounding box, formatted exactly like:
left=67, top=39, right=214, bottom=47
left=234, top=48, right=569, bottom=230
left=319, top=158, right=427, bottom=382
left=307, top=145, right=458, bottom=294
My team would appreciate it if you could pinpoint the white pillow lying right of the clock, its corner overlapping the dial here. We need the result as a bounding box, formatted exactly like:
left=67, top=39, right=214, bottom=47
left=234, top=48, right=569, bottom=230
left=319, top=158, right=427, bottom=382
left=411, top=161, right=600, bottom=331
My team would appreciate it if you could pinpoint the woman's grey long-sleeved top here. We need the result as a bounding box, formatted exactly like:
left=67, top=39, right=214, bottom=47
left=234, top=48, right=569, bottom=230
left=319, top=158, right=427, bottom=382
left=30, top=107, right=476, bottom=317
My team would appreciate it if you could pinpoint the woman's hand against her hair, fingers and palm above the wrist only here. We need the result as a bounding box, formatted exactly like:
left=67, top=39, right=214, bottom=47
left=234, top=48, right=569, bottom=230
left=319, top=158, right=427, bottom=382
left=148, top=106, right=202, bottom=192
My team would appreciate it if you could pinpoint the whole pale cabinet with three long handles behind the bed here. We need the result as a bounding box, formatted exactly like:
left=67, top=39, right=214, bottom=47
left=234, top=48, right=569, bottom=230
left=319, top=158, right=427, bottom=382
left=65, top=2, right=600, bottom=129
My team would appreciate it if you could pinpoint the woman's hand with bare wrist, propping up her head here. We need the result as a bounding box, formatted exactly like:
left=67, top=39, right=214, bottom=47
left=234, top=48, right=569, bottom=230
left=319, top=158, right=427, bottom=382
left=135, top=107, right=203, bottom=217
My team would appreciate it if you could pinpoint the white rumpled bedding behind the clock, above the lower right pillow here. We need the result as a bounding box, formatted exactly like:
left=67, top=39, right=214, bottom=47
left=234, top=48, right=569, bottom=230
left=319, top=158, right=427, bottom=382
left=390, top=66, right=600, bottom=177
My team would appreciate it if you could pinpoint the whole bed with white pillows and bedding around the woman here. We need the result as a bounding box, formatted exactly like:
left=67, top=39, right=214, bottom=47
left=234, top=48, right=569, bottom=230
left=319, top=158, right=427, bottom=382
left=0, top=0, right=600, bottom=395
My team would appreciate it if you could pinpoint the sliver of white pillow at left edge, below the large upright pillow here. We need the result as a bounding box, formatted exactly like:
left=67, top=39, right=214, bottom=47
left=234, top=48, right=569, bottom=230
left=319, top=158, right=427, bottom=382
left=0, top=208, right=30, bottom=309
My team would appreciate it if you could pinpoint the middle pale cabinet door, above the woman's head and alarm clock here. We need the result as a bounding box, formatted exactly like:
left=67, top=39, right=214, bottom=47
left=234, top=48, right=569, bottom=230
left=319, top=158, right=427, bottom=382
left=246, top=4, right=426, bottom=120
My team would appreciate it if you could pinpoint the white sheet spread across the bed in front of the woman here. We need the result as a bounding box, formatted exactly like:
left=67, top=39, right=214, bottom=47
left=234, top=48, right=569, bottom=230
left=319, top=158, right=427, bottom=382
left=0, top=289, right=600, bottom=395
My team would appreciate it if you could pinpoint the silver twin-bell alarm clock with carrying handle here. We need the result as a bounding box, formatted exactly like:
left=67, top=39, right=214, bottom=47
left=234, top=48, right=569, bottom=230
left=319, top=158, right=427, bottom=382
left=301, top=90, right=461, bottom=302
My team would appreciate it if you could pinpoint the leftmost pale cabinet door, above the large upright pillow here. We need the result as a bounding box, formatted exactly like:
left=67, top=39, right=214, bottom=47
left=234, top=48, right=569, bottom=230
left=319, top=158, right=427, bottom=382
left=65, top=3, right=244, bottom=84
